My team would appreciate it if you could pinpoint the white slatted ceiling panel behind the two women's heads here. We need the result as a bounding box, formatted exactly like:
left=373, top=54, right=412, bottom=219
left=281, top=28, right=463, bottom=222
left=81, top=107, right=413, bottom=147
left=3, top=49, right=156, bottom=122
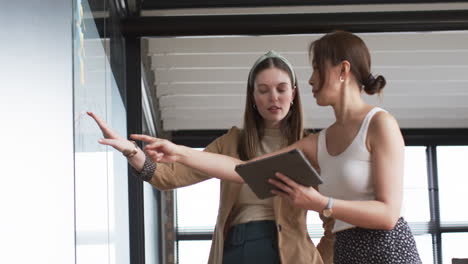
left=144, top=31, right=468, bottom=130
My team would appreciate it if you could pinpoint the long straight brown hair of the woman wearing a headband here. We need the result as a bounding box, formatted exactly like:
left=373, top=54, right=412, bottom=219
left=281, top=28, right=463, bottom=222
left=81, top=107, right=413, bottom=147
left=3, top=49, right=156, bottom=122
left=238, top=57, right=304, bottom=160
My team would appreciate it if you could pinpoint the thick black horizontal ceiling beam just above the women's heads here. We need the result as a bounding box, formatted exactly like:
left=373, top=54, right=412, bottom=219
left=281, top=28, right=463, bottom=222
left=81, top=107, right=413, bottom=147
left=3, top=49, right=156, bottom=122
left=122, top=10, right=468, bottom=37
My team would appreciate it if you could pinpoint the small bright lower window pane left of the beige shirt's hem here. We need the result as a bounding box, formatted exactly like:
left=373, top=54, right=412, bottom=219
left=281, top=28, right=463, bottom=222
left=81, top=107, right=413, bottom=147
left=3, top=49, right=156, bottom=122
left=176, top=240, right=211, bottom=264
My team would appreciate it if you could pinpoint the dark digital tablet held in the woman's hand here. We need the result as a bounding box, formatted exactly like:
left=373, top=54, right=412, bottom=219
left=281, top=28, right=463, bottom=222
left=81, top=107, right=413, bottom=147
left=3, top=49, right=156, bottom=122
left=235, top=149, right=323, bottom=199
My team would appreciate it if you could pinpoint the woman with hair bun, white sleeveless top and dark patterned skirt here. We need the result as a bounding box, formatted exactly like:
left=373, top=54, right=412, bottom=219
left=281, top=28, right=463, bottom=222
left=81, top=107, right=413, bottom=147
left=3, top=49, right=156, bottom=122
left=137, top=31, right=421, bottom=264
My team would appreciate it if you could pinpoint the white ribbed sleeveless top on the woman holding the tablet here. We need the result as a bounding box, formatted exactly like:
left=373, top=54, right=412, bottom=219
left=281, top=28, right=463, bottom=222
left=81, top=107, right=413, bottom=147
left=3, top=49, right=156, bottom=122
left=317, top=107, right=385, bottom=232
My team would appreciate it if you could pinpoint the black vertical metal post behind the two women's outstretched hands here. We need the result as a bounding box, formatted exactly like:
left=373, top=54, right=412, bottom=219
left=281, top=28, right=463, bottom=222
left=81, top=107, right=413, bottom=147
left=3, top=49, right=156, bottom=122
left=108, top=0, right=152, bottom=264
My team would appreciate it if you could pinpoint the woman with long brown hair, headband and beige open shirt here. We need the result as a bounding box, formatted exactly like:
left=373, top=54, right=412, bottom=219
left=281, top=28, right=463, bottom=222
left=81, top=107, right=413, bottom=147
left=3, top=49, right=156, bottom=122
left=89, top=51, right=334, bottom=264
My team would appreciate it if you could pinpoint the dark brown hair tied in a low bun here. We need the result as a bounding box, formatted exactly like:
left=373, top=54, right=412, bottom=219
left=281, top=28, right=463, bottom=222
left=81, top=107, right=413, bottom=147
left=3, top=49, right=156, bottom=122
left=309, top=31, right=386, bottom=95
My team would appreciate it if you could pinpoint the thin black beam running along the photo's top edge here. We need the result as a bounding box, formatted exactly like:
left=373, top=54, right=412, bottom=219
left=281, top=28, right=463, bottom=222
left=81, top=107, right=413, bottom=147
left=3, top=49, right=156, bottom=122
left=142, top=0, right=466, bottom=10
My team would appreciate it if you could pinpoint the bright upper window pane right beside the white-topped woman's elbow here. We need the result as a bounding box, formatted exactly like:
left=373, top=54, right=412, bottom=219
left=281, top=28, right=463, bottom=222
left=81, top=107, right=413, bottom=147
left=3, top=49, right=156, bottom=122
left=403, top=147, right=430, bottom=222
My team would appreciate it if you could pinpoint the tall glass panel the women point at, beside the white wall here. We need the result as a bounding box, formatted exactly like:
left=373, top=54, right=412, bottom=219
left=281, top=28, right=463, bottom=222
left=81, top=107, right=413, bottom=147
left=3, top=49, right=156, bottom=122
left=73, top=0, right=129, bottom=264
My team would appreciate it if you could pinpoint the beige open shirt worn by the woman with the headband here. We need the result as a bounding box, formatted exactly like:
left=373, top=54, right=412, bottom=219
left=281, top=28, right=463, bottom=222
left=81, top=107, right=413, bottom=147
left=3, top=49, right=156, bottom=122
left=149, top=127, right=334, bottom=264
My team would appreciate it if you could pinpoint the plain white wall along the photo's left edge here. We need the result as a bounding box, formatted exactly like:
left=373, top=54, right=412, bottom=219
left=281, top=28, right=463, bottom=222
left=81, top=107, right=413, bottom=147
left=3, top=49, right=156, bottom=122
left=0, top=0, right=75, bottom=264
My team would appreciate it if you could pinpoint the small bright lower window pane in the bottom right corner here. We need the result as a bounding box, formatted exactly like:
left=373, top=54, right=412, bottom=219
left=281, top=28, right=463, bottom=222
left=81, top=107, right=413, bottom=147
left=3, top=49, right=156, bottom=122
left=442, top=233, right=468, bottom=263
